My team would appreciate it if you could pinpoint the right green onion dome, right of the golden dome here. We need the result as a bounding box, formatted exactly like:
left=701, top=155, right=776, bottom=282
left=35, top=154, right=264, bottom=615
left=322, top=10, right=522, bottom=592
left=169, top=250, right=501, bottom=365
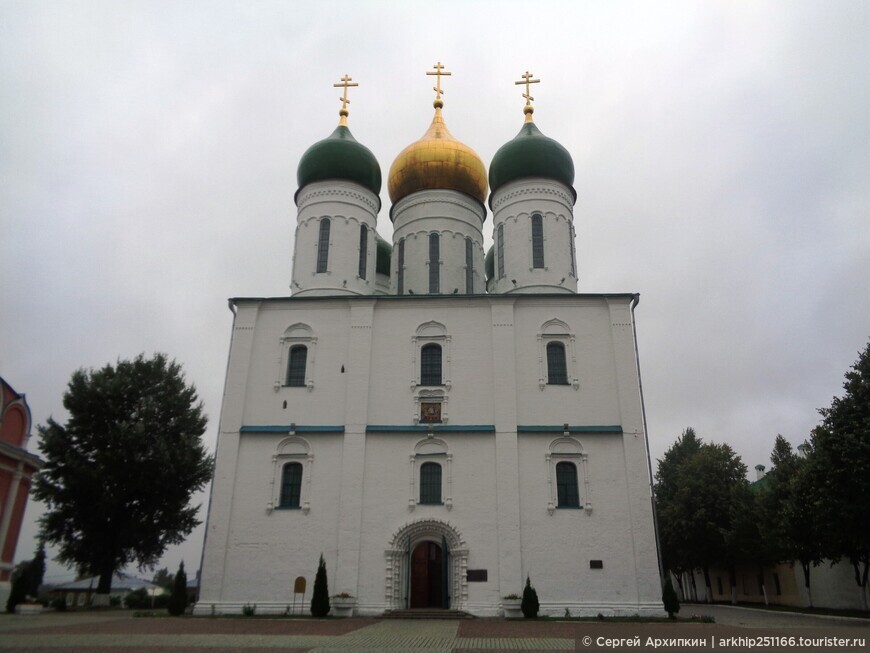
left=489, top=119, right=577, bottom=200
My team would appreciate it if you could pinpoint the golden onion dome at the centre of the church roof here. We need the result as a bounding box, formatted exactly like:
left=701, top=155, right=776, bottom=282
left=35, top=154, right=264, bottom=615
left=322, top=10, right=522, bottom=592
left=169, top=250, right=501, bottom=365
left=387, top=98, right=487, bottom=204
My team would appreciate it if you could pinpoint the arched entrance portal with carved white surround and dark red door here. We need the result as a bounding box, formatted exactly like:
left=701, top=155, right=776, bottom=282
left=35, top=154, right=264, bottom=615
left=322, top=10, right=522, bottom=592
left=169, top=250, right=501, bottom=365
left=384, top=519, right=468, bottom=610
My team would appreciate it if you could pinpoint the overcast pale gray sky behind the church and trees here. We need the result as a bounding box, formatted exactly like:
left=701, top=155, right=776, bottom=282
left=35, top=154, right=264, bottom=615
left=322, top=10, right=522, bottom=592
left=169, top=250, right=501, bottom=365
left=0, top=0, right=870, bottom=580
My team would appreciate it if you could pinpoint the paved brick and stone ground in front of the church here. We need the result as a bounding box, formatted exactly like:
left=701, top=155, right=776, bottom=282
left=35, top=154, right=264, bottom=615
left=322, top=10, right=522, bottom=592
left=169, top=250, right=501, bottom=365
left=0, top=606, right=870, bottom=653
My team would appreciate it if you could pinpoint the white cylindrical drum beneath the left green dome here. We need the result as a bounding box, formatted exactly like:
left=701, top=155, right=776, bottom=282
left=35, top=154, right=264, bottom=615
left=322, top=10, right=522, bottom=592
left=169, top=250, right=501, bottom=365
left=291, top=180, right=380, bottom=296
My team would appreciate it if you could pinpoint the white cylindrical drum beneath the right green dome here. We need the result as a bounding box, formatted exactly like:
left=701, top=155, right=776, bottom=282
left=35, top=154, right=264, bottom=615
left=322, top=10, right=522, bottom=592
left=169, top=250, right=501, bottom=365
left=488, top=177, right=577, bottom=293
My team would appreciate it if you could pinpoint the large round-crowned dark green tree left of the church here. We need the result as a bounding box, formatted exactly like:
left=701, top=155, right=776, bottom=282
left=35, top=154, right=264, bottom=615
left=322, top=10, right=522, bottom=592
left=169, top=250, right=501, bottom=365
left=33, top=354, right=212, bottom=604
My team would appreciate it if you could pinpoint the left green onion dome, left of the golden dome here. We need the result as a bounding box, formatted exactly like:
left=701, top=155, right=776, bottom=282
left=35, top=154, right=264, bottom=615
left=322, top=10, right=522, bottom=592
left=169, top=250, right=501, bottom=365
left=296, top=124, right=381, bottom=206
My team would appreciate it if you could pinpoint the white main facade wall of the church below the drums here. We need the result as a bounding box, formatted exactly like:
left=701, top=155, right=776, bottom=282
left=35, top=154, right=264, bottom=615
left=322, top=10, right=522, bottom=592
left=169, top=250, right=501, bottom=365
left=196, top=294, right=661, bottom=615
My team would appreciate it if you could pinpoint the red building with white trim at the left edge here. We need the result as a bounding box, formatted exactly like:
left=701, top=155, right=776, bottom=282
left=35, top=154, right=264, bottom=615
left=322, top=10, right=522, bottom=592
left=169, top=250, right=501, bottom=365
left=0, top=377, right=42, bottom=606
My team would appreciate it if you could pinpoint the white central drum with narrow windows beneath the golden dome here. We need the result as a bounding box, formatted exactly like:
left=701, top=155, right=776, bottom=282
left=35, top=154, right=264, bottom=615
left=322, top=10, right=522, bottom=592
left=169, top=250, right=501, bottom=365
left=390, top=190, right=486, bottom=295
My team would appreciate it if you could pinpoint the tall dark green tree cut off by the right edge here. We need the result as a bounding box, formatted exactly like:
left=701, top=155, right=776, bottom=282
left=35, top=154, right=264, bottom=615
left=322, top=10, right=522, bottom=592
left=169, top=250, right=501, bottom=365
left=808, top=343, right=870, bottom=599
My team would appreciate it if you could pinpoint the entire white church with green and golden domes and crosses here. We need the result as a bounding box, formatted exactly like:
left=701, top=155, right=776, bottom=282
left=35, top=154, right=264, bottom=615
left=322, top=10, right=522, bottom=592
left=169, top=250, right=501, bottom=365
left=195, top=71, right=662, bottom=616
